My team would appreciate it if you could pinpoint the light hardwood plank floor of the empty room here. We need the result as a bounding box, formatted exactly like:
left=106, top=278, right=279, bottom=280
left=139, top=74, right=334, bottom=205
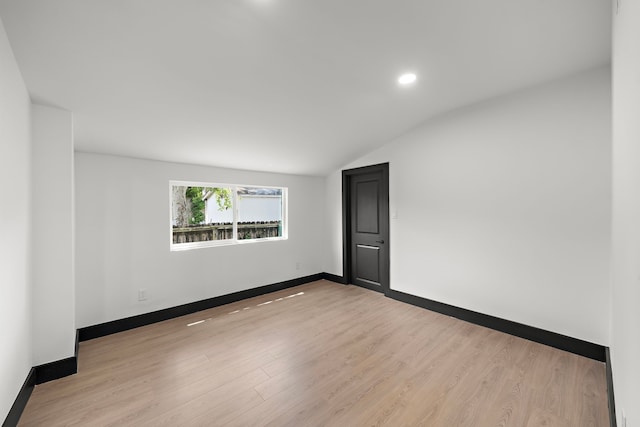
left=20, top=281, right=608, bottom=427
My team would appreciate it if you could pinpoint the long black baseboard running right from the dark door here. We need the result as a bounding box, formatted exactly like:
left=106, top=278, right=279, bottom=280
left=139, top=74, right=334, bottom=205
left=387, top=289, right=605, bottom=362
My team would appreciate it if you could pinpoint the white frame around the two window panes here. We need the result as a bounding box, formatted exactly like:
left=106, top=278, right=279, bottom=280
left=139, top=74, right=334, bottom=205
left=169, top=180, right=289, bottom=252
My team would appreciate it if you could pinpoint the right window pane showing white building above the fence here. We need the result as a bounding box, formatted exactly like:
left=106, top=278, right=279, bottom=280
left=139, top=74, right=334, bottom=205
left=236, top=187, right=283, bottom=240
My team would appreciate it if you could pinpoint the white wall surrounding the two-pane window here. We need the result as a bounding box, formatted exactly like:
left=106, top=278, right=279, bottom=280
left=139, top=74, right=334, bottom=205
left=76, top=153, right=324, bottom=327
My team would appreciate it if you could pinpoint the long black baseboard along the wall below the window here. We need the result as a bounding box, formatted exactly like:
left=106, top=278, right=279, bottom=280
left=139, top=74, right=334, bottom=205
left=79, top=273, right=323, bottom=341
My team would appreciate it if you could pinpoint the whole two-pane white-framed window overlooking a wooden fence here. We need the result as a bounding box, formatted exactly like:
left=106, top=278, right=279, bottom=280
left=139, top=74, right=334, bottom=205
left=170, top=181, right=287, bottom=250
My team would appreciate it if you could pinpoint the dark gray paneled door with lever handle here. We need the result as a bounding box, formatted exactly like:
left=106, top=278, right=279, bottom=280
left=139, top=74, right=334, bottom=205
left=345, top=164, right=389, bottom=293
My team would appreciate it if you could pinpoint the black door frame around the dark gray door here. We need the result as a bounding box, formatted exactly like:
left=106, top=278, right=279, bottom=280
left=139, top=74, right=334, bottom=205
left=342, top=162, right=390, bottom=295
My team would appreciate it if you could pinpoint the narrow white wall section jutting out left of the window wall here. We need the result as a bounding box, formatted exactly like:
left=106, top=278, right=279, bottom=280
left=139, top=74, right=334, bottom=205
left=32, top=104, right=76, bottom=365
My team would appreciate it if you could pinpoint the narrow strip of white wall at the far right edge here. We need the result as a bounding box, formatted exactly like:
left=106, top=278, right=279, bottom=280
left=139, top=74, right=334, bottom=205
left=611, top=1, right=640, bottom=427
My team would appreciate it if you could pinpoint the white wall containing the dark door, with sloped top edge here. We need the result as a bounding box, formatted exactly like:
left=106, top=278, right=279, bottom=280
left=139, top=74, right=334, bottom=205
left=325, top=67, right=611, bottom=344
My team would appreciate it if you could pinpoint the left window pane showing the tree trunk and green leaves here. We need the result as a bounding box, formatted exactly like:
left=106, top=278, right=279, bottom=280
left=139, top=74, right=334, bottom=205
left=171, top=185, right=233, bottom=244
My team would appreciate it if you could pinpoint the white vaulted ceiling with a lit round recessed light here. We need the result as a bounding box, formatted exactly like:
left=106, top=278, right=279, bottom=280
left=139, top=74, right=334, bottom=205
left=0, top=0, right=611, bottom=174
